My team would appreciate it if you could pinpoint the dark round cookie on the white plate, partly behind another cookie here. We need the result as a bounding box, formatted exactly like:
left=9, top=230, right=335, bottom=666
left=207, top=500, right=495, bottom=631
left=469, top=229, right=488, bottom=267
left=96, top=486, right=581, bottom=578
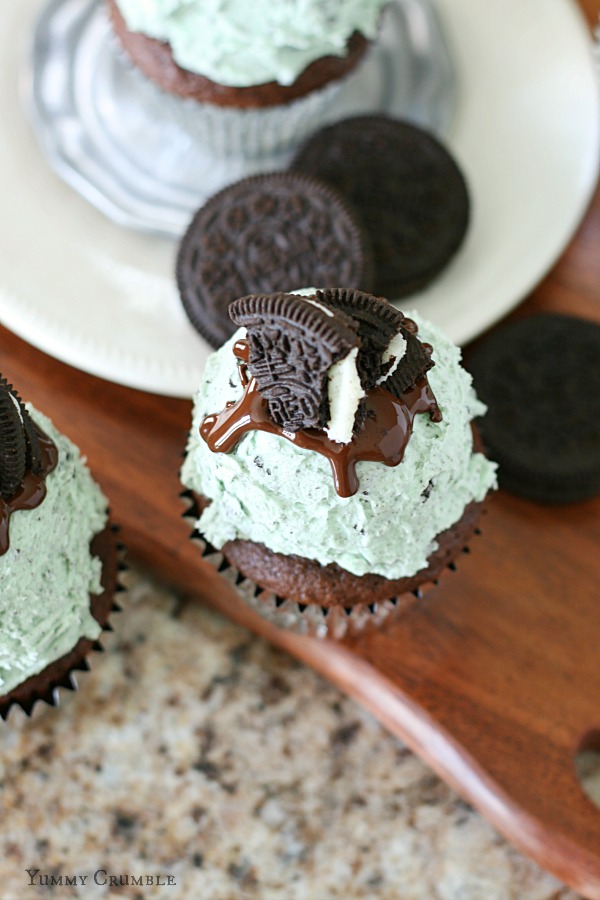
left=291, top=116, right=470, bottom=298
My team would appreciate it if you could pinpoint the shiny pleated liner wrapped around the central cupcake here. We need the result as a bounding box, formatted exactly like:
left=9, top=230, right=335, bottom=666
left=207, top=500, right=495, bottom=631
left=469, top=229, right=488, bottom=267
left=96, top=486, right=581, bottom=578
left=180, top=490, right=481, bottom=640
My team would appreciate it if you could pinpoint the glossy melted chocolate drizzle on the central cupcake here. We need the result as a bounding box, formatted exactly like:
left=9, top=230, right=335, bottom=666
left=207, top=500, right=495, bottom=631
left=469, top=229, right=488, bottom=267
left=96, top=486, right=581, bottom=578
left=200, top=340, right=442, bottom=497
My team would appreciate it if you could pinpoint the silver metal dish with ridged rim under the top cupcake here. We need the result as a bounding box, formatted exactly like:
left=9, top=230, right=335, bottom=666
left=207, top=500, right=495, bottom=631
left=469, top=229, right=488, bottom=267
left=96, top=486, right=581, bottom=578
left=29, top=0, right=455, bottom=237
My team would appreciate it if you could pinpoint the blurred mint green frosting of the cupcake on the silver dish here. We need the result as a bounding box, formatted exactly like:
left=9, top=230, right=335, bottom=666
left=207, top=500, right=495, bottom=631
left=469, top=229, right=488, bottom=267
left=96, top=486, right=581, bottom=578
left=117, top=0, right=387, bottom=87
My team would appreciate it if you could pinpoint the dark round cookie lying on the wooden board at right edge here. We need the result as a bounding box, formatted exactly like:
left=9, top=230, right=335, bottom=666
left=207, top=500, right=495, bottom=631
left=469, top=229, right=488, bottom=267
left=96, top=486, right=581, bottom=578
left=466, top=314, right=600, bottom=503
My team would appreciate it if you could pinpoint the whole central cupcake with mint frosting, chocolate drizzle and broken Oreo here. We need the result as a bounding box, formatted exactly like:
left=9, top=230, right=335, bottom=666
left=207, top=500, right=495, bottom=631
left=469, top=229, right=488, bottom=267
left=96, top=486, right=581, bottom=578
left=182, top=289, right=496, bottom=634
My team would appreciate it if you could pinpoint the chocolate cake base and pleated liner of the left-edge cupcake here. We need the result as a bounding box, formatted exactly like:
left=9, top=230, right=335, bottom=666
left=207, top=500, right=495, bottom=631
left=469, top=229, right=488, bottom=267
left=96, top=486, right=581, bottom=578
left=0, top=523, right=127, bottom=719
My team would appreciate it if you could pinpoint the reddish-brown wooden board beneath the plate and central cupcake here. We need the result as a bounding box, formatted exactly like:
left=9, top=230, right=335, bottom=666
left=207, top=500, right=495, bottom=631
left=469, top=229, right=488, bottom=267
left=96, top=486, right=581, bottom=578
left=0, top=0, right=600, bottom=898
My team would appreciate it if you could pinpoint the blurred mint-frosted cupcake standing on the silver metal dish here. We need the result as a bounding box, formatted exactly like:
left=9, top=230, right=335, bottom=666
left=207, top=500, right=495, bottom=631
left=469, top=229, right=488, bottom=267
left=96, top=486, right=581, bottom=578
left=107, top=0, right=387, bottom=157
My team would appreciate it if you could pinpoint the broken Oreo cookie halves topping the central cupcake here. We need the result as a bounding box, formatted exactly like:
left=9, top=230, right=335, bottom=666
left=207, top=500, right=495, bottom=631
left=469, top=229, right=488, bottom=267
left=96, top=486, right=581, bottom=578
left=229, top=288, right=433, bottom=442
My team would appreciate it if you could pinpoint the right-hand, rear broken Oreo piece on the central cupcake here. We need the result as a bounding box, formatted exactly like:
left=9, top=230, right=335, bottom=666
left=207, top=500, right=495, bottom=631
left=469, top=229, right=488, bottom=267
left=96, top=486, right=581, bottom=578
left=316, top=288, right=434, bottom=397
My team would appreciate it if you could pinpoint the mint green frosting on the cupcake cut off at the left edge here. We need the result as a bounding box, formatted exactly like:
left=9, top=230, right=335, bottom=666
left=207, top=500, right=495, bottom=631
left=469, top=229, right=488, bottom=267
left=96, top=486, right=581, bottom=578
left=0, top=406, right=107, bottom=695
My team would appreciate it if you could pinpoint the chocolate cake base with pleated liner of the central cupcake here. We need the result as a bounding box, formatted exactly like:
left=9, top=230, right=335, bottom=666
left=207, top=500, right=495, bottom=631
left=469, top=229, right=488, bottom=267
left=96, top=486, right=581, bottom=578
left=181, top=491, right=483, bottom=639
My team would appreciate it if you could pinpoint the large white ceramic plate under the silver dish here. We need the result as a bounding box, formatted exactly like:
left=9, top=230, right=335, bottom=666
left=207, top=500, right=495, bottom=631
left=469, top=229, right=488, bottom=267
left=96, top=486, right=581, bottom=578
left=0, top=0, right=600, bottom=396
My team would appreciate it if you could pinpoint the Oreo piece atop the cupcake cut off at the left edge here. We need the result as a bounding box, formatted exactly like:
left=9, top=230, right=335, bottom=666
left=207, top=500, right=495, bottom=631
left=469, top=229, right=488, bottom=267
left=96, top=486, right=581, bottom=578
left=0, top=376, right=40, bottom=500
